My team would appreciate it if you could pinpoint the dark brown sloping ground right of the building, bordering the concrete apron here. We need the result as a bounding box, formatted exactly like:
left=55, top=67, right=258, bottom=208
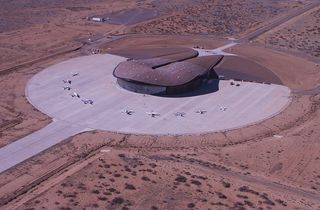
left=214, top=56, right=282, bottom=85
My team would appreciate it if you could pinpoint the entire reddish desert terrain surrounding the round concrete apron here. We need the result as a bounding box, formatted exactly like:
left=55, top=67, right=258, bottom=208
left=0, top=0, right=320, bottom=210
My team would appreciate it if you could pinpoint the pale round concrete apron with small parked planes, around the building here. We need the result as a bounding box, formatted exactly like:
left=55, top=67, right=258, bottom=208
left=26, top=54, right=290, bottom=135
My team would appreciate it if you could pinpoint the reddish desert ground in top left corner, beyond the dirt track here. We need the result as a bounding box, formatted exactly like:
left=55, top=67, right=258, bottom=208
left=0, top=0, right=142, bottom=70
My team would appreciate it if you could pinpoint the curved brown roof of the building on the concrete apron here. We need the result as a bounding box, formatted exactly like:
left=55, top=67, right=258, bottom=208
left=114, top=55, right=223, bottom=86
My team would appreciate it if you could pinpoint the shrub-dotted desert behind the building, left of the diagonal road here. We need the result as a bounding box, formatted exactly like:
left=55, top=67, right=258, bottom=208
left=127, top=0, right=310, bottom=37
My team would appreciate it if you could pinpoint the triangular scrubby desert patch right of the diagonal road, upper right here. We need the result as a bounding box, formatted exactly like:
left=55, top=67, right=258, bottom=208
left=255, top=7, right=320, bottom=58
